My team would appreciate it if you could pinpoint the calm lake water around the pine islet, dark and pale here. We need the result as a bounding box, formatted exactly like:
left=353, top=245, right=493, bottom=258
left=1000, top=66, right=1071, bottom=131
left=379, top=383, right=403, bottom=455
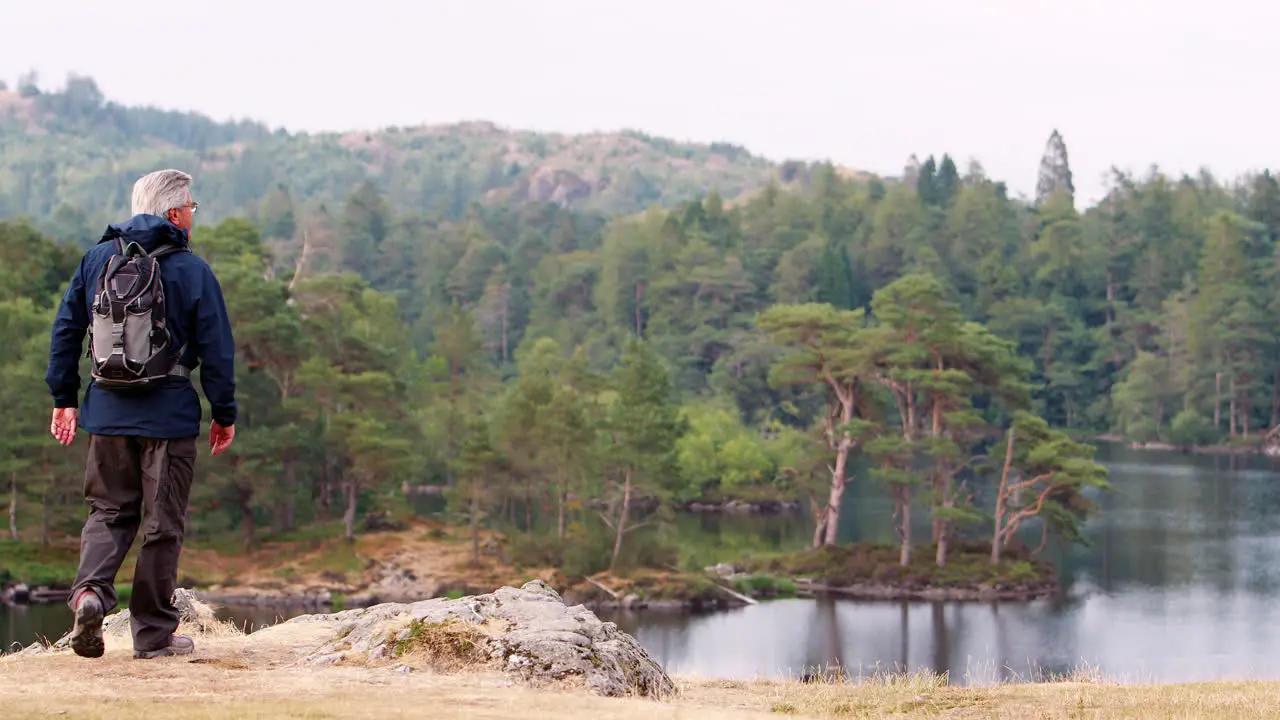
left=0, top=446, right=1280, bottom=684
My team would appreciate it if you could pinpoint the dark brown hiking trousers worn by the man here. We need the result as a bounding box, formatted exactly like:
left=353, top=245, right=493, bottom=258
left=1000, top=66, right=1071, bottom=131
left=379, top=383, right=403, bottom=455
left=69, top=436, right=196, bottom=651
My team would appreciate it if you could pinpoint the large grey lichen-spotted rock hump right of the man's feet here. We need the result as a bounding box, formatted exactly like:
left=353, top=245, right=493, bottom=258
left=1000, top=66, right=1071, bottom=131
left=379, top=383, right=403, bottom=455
left=268, top=580, right=675, bottom=696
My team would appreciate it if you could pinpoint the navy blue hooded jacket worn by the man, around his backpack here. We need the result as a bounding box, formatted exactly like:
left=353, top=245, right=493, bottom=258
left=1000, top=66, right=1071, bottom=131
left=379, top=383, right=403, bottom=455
left=45, top=215, right=236, bottom=439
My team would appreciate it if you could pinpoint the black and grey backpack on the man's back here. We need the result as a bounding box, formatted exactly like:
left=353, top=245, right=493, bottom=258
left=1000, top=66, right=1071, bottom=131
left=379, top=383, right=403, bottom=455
left=86, top=237, right=191, bottom=392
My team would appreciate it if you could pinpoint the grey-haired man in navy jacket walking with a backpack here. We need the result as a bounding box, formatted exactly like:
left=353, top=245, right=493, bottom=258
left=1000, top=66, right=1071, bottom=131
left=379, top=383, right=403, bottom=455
left=45, top=170, right=236, bottom=659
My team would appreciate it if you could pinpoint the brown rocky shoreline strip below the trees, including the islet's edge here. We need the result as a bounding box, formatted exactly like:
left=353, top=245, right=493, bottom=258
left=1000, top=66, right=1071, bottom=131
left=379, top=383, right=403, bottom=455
left=0, top=520, right=1059, bottom=612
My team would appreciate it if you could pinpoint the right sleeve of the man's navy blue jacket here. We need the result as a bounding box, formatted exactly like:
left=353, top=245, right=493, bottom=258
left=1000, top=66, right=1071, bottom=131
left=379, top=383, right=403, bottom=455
left=196, top=260, right=236, bottom=428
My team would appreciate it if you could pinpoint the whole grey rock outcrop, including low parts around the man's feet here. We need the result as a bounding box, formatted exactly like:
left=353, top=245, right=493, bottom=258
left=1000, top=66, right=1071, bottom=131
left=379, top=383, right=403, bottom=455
left=18, top=580, right=676, bottom=697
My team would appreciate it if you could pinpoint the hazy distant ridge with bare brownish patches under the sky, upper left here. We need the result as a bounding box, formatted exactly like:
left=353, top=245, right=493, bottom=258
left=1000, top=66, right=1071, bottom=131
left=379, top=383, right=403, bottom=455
left=0, top=76, right=849, bottom=225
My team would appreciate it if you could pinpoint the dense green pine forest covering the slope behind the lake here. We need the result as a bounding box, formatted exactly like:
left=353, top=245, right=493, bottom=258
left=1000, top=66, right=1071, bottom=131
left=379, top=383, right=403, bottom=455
left=0, top=77, right=1280, bottom=569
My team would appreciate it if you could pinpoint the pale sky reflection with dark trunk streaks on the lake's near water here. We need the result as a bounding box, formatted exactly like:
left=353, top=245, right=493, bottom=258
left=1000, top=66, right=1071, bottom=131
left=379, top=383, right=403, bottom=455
left=608, top=592, right=1280, bottom=684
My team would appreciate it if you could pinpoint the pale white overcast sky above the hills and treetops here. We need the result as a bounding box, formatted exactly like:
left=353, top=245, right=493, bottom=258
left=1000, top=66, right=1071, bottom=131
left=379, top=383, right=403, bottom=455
left=0, top=0, right=1280, bottom=202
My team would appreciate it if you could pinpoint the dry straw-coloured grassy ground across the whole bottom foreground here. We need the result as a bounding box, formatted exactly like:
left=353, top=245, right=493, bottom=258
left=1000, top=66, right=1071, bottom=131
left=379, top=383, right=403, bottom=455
left=0, top=639, right=1280, bottom=720
